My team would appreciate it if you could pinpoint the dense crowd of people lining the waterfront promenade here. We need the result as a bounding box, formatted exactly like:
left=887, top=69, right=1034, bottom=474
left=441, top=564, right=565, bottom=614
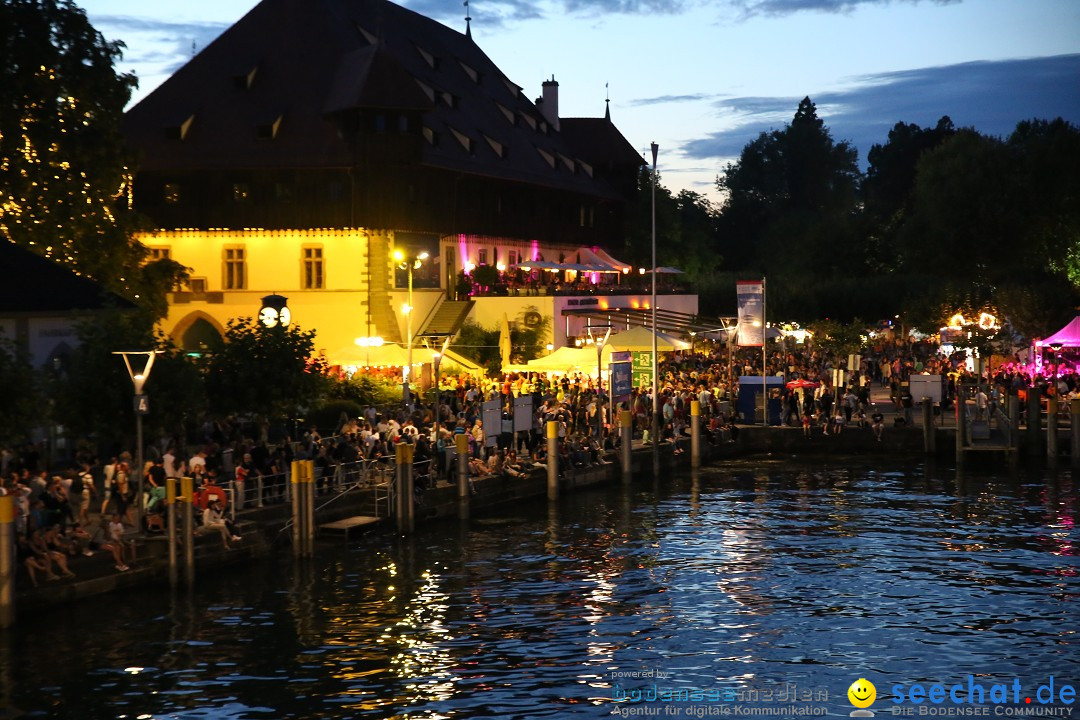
left=0, top=330, right=1067, bottom=585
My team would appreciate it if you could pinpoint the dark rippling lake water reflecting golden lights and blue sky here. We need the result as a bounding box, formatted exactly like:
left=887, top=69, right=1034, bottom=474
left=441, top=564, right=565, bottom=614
left=0, top=462, right=1080, bottom=720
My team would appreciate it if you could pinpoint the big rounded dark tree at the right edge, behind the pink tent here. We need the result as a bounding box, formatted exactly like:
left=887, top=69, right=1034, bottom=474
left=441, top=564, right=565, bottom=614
left=896, top=119, right=1080, bottom=336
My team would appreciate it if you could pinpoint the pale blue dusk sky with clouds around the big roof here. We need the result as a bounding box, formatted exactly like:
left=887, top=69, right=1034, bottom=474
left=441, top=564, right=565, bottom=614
left=86, top=0, right=1080, bottom=199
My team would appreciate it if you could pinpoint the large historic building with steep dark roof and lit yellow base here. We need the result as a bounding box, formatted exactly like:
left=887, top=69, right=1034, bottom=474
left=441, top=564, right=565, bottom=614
left=125, top=0, right=697, bottom=364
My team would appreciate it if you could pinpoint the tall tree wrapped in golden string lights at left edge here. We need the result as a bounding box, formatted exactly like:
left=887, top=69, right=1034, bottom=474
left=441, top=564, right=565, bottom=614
left=0, top=0, right=184, bottom=318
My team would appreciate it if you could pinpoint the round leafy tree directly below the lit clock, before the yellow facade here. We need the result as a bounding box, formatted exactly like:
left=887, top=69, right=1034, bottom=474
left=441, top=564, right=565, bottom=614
left=205, top=317, right=328, bottom=419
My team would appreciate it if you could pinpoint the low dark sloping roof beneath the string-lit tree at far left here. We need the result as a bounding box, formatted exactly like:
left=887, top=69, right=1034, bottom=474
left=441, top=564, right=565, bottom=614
left=0, top=241, right=135, bottom=314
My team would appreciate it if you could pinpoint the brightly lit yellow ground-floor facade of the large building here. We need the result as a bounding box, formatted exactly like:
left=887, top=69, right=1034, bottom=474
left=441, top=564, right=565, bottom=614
left=139, top=229, right=442, bottom=362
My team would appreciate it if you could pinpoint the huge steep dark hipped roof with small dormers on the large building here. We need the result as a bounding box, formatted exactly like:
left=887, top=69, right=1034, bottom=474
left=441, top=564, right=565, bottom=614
left=125, top=0, right=621, bottom=198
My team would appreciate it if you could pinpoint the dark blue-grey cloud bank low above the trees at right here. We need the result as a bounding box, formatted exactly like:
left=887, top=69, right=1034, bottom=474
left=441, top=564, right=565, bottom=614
left=681, top=54, right=1080, bottom=163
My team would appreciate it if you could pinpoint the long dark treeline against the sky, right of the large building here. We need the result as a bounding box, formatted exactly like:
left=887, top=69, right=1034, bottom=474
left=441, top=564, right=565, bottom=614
left=623, top=98, right=1080, bottom=337
